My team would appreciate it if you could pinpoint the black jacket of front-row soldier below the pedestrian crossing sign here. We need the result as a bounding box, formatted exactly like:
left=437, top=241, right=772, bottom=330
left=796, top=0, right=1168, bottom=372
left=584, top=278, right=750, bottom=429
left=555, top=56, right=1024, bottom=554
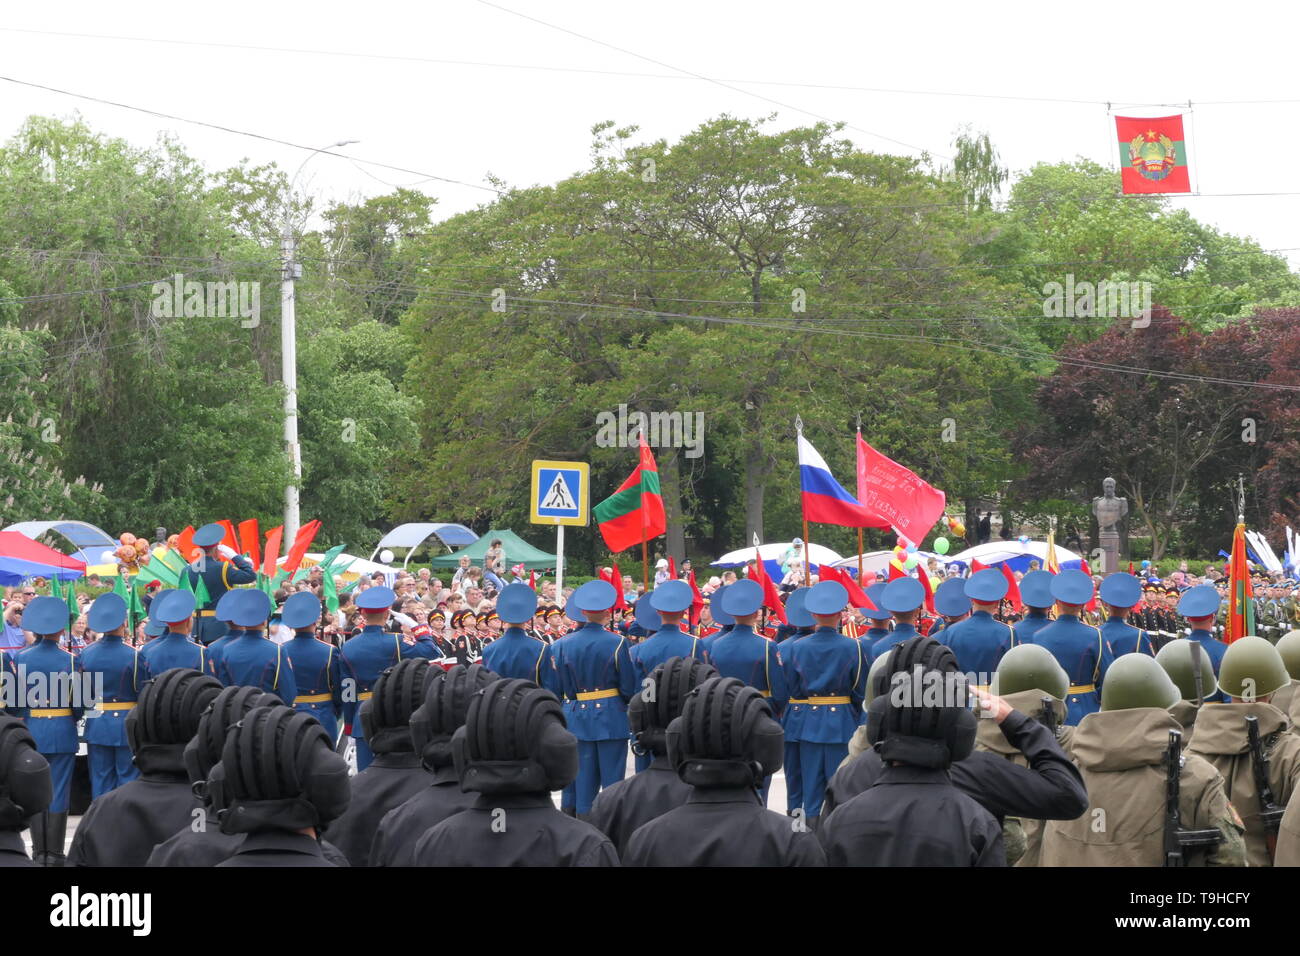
left=415, top=793, right=619, bottom=866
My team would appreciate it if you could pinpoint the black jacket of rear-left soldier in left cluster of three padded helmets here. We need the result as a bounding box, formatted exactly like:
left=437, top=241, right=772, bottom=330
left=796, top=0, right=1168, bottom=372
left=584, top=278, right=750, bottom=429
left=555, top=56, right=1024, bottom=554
left=68, top=747, right=200, bottom=866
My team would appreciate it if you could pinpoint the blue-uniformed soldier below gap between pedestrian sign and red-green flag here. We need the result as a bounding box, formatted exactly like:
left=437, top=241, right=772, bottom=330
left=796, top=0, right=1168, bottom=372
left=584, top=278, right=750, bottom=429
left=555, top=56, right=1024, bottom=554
left=551, top=580, right=640, bottom=818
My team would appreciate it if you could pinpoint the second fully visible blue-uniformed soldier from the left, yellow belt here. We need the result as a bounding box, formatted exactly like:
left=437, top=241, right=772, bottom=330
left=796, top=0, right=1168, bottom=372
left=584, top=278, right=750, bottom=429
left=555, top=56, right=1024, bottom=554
left=81, top=592, right=151, bottom=800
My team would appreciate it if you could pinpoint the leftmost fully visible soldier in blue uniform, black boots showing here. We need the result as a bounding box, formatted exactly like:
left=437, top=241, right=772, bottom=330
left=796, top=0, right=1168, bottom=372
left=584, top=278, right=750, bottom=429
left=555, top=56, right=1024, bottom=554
left=14, top=597, right=82, bottom=866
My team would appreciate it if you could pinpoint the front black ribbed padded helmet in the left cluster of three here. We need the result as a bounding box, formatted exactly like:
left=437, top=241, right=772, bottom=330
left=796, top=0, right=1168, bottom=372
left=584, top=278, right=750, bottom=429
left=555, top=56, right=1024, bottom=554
left=208, top=704, right=352, bottom=834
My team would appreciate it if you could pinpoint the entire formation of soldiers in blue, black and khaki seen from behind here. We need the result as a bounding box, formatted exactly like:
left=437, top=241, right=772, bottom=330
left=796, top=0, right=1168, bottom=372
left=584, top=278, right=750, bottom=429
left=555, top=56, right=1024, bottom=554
left=0, top=525, right=1300, bottom=866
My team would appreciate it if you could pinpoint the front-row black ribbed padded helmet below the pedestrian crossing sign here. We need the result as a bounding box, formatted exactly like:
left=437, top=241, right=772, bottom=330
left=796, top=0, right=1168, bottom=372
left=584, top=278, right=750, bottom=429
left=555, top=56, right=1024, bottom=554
left=451, top=680, right=577, bottom=793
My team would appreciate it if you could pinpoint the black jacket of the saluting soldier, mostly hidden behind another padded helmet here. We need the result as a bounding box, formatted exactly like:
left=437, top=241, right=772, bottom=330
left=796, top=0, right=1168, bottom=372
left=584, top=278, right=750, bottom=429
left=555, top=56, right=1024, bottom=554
left=822, top=710, right=1088, bottom=825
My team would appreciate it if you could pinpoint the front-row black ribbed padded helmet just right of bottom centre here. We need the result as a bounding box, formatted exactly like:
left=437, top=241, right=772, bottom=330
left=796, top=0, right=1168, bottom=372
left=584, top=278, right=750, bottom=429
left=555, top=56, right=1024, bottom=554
left=666, top=676, right=785, bottom=788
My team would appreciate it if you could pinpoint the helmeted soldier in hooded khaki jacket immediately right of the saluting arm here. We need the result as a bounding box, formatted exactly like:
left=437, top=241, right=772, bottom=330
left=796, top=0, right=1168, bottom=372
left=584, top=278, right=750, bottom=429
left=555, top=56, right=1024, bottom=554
left=1041, top=654, right=1245, bottom=866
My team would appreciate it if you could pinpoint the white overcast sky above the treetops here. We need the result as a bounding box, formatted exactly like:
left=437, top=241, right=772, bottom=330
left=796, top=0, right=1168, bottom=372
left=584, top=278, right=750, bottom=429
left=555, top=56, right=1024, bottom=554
left=0, top=0, right=1300, bottom=264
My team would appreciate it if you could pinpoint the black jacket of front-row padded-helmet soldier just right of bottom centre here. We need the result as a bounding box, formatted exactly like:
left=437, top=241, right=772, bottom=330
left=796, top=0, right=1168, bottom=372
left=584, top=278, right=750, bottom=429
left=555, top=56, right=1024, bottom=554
left=623, top=787, right=826, bottom=866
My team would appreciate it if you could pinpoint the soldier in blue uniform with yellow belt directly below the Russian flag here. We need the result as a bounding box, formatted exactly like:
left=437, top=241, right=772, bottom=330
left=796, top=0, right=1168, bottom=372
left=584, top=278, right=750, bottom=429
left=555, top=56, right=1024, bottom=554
left=790, top=581, right=863, bottom=826
